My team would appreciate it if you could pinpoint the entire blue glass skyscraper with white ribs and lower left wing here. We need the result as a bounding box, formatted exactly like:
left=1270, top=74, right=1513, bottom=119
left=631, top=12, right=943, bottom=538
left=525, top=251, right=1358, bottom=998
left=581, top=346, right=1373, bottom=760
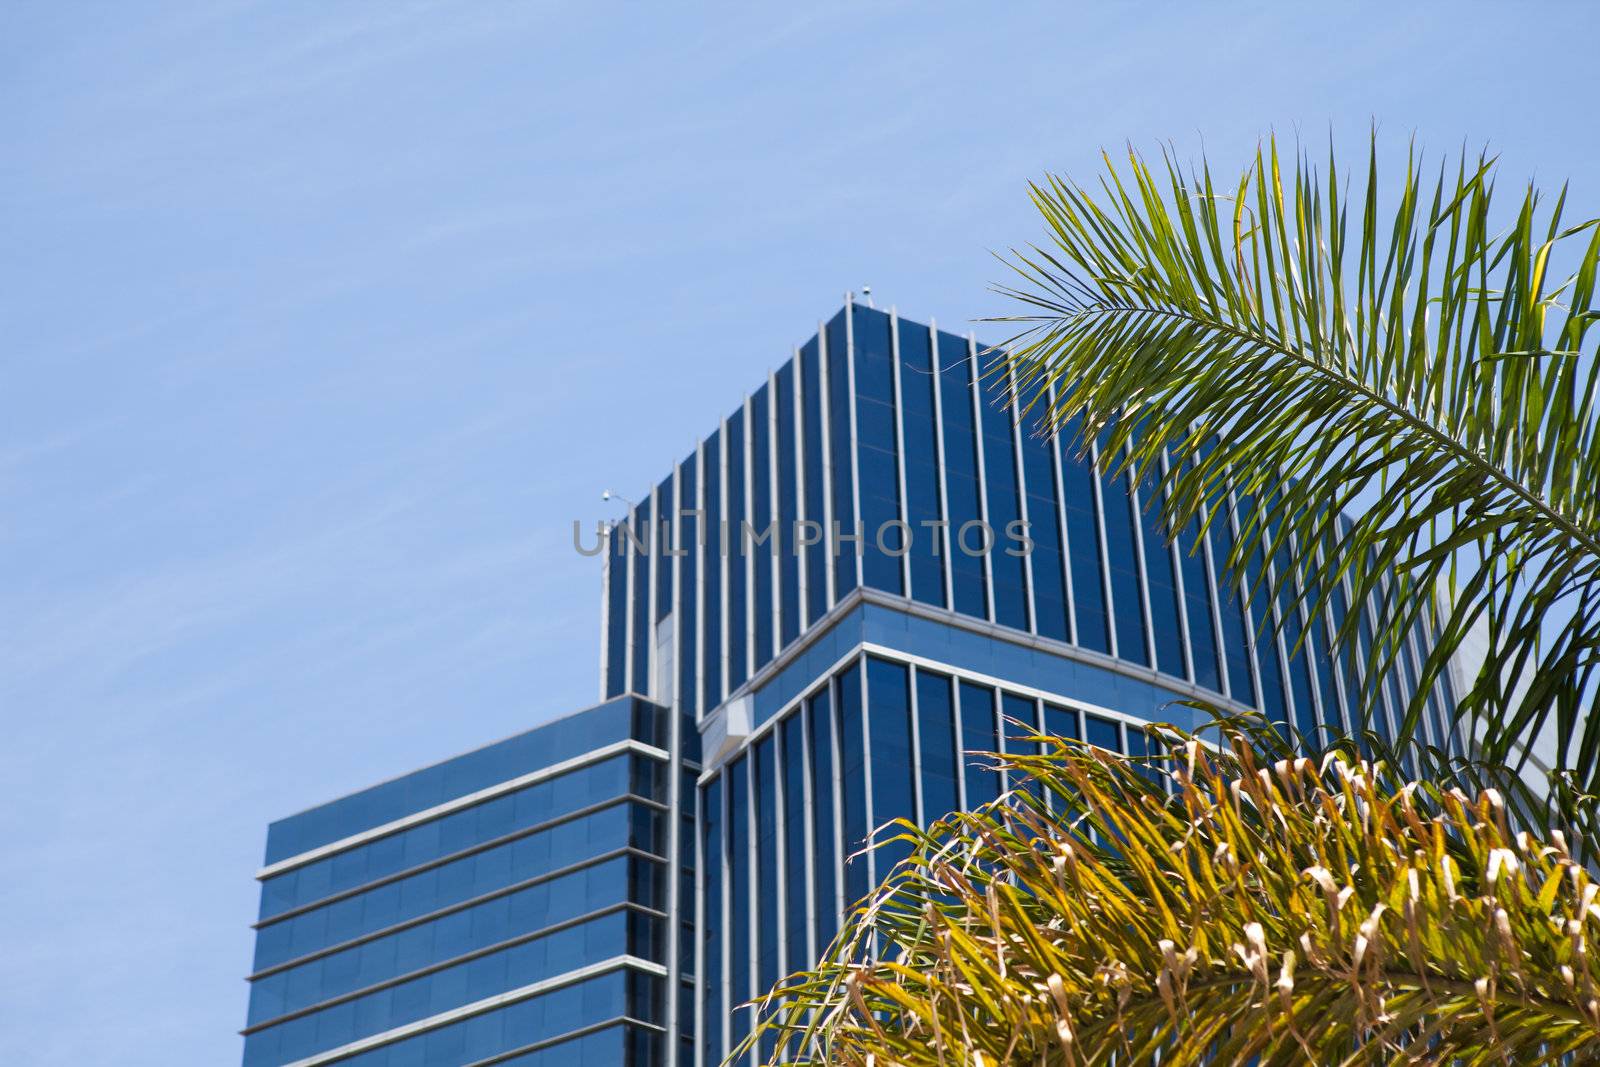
left=245, top=301, right=1448, bottom=1067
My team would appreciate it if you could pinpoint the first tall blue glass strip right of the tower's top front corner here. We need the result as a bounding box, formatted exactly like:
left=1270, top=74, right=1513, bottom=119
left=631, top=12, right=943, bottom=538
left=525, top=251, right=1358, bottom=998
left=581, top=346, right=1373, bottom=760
left=854, top=307, right=907, bottom=595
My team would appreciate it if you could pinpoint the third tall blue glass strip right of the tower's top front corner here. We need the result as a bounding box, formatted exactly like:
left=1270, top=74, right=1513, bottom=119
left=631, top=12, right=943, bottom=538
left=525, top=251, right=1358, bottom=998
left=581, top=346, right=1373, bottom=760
left=938, top=333, right=989, bottom=619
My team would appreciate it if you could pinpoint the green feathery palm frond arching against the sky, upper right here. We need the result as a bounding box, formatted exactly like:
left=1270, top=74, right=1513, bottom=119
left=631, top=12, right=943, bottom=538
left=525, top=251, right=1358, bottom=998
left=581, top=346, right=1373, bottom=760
left=1002, top=133, right=1600, bottom=806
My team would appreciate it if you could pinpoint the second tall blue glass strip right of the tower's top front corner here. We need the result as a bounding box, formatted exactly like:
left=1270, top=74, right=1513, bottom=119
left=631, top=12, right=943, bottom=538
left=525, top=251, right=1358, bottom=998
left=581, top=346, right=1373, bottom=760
left=899, top=323, right=946, bottom=608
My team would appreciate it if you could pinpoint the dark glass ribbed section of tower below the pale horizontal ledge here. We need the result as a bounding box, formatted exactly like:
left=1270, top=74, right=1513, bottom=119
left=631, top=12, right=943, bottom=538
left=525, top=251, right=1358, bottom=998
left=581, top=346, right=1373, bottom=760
left=696, top=643, right=1178, bottom=1067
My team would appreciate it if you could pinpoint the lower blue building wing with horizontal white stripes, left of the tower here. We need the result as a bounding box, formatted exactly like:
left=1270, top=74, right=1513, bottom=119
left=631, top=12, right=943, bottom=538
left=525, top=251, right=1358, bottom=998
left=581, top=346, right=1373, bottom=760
left=243, top=697, right=696, bottom=1067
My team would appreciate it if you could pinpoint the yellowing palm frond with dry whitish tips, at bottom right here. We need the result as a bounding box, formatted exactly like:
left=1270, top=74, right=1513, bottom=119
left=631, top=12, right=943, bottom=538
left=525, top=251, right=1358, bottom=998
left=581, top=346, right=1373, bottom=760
left=747, top=725, right=1600, bottom=1067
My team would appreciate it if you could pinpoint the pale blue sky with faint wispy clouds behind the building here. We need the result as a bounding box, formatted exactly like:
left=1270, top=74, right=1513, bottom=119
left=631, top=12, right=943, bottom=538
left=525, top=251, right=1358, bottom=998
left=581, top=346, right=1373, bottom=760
left=0, top=0, right=1600, bottom=1067
